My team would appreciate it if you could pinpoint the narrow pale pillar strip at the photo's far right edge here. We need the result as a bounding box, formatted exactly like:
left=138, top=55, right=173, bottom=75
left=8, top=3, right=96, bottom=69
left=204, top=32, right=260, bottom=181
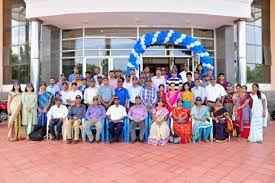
left=270, top=0, right=275, bottom=90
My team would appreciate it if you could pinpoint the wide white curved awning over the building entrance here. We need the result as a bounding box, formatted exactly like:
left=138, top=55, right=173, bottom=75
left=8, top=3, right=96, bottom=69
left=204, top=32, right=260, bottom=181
left=26, top=0, right=251, bottom=29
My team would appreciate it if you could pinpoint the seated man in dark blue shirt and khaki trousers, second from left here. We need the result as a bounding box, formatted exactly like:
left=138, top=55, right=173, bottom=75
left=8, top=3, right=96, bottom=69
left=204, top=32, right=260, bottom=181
left=64, top=95, right=86, bottom=144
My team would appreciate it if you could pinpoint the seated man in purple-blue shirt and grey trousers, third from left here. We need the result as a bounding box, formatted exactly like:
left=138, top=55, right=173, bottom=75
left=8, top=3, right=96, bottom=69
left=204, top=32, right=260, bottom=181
left=82, top=96, right=106, bottom=143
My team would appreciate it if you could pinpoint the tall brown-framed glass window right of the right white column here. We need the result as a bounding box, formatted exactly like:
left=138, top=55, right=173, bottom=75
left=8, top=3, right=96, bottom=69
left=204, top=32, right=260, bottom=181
left=246, top=0, right=271, bottom=83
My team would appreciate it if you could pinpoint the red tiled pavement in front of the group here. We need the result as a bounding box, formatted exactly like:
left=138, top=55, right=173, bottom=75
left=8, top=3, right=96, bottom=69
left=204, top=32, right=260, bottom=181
left=0, top=123, right=275, bottom=183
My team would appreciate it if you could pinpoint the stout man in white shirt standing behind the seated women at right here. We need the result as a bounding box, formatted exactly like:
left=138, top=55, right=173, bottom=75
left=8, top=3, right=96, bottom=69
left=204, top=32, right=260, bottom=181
left=205, top=77, right=227, bottom=107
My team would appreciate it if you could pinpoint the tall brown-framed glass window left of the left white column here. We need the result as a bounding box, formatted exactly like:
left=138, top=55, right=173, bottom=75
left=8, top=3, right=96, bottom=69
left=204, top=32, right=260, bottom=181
left=3, top=0, right=30, bottom=84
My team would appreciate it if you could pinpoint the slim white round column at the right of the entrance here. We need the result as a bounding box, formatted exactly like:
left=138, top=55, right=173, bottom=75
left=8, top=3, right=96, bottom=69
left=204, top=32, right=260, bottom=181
left=237, top=20, right=247, bottom=85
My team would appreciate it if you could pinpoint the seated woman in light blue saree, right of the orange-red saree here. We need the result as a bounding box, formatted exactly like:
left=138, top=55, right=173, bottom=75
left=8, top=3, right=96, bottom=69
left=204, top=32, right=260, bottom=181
left=191, top=97, right=213, bottom=142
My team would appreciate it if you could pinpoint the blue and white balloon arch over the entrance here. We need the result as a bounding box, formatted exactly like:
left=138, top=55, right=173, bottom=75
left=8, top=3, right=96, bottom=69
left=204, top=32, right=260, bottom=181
left=127, top=30, right=214, bottom=74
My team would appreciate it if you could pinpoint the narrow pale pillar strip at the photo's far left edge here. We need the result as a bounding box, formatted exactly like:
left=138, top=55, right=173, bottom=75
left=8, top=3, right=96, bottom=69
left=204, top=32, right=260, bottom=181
left=0, top=0, right=4, bottom=86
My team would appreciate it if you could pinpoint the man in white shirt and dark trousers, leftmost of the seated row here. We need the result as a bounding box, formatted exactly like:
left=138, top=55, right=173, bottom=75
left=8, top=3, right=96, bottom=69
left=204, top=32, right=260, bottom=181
left=47, top=97, right=68, bottom=140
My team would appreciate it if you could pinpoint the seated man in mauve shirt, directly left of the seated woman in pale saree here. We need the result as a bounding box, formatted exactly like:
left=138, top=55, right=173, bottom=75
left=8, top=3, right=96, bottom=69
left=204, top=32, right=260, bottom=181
left=128, top=96, right=148, bottom=142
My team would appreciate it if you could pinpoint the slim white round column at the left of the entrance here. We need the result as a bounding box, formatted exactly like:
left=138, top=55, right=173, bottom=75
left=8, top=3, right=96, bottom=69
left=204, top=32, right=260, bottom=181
left=29, top=20, right=41, bottom=91
